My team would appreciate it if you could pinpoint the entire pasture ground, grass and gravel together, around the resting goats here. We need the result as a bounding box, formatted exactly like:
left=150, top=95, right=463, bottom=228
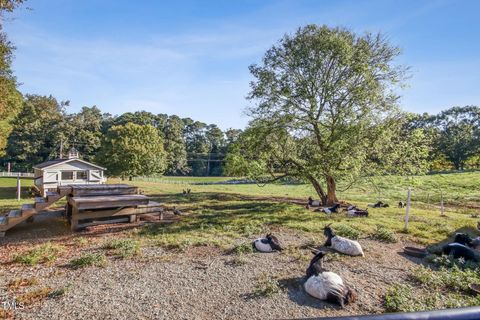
left=0, top=172, right=480, bottom=318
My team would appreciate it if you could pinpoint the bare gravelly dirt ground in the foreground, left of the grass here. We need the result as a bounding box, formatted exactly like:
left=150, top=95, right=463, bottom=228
left=0, top=215, right=420, bottom=319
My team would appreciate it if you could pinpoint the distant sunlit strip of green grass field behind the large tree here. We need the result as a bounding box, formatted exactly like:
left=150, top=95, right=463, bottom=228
left=123, top=172, right=480, bottom=207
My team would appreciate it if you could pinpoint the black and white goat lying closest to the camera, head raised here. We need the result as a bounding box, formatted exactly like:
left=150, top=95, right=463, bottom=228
left=304, top=251, right=357, bottom=308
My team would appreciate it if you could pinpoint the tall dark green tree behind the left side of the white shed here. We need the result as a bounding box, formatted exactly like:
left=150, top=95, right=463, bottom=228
left=7, top=95, right=65, bottom=170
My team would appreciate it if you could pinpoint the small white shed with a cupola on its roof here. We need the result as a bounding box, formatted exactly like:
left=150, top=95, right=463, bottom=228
left=33, top=148, right=106, bottom=197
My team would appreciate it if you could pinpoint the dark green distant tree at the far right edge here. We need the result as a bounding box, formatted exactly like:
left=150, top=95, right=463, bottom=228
left=432, top=106, right=480, bottom=170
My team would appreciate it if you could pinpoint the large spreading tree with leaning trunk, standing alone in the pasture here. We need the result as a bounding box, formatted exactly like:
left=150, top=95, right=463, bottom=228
left=228, top=25, right=418, bottom=203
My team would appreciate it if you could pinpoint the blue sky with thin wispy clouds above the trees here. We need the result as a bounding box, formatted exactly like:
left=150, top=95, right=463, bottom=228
left=5, top=0, right=480, bottom=129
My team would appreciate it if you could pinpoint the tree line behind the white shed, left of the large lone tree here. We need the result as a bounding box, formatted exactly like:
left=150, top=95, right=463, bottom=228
left=2, top=95, right=240, bottom=177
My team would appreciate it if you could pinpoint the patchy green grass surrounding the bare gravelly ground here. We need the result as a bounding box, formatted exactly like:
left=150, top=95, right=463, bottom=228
left=0, top=172, right=480, bottom=314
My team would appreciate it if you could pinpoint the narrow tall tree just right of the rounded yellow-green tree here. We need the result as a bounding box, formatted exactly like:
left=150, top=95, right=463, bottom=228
left=162, top=116, right=189, bottom=175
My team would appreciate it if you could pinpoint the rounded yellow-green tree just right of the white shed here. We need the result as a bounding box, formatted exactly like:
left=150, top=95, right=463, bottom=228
left=96, top=122, right=166, bottom=179
